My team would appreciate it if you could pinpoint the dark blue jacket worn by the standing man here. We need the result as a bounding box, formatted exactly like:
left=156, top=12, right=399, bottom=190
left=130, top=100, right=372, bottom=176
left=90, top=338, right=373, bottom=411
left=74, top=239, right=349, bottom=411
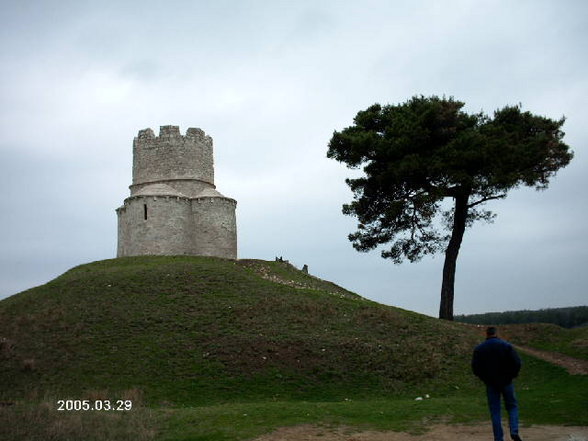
left=472, top=337, right=521, bottom=386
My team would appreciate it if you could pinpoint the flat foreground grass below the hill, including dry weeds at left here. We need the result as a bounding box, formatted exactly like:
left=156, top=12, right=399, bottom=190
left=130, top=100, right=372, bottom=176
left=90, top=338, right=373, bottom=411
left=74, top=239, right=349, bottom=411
left=0, top=350, right=588, bottom=441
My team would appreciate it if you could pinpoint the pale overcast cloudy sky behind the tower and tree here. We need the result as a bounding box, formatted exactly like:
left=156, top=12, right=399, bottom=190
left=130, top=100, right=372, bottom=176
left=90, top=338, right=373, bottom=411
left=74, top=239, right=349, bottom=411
left=0, top=0, right=588, bottom=316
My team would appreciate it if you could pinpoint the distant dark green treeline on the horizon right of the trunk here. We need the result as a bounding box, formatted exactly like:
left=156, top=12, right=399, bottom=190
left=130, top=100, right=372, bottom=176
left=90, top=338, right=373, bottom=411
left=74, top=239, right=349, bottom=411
left=455, top=306, right=588, bottom=328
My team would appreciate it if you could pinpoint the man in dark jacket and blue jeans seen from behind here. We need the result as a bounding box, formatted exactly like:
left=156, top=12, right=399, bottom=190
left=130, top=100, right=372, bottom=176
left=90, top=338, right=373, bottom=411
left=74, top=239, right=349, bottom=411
left=472, top=326, right=521, bottom=441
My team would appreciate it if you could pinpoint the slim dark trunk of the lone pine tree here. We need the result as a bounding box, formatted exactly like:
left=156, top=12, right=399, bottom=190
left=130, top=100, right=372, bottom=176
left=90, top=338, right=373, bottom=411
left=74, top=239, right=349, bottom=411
left=439, top=192, right=470, bottom=320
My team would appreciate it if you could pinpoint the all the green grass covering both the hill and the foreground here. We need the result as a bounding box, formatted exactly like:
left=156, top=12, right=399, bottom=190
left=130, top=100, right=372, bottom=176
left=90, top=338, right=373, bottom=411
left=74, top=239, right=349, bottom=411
left=0, top=253, right=588, bottom=440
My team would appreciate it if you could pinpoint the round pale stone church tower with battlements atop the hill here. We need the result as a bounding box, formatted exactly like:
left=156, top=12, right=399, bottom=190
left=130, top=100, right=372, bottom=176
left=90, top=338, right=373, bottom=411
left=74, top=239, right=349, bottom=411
left=116, top=126, right=237, bottom=259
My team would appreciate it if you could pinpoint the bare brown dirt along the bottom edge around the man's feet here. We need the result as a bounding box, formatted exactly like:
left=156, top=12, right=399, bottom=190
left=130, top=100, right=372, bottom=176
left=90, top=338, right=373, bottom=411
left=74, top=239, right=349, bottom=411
left=255, top=423, right=588, bottom=441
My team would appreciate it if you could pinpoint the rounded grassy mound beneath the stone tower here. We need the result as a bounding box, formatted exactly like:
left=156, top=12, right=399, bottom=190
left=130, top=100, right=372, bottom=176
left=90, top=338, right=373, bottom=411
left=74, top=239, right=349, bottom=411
left=0, top=257, right=479, bottom=405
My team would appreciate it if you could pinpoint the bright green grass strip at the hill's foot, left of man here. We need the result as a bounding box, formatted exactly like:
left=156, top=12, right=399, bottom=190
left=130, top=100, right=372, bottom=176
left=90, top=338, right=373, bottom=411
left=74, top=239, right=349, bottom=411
left=155, top=398, right=483, bottom=441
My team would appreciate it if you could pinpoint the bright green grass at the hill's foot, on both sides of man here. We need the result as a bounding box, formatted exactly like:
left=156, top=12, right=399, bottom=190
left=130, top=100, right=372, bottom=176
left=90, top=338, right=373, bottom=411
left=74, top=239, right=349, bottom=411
left=153, top=355, right=588, bottom=441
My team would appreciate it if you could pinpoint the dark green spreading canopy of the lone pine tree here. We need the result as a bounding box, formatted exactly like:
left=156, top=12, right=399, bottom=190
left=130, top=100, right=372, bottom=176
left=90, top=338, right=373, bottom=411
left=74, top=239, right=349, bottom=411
left=327, top=96, right=573, bottom=263
